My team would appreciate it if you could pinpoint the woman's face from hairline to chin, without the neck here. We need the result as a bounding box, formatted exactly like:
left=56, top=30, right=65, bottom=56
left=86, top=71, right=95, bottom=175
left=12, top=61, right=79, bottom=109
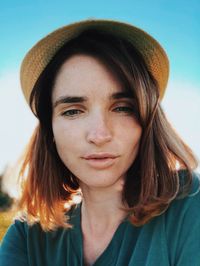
left=52, top=54, right=142, bottom=188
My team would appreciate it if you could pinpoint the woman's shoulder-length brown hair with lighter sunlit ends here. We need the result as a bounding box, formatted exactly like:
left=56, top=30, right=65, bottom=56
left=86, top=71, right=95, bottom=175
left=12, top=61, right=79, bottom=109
left=19, top=30, right=197, bottom=230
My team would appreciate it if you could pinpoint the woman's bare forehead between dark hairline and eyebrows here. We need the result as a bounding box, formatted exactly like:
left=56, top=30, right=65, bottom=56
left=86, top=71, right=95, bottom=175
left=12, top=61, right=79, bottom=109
left=53, top=54, right=130, bottom=101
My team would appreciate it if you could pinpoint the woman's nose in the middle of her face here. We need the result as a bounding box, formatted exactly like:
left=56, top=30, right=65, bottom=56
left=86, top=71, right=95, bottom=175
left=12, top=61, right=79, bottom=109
left=87, top=112, right=112, bottom=146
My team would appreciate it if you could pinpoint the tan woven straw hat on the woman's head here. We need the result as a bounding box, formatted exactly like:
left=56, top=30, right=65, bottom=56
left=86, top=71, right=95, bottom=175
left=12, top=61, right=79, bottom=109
left=20, top=19, right=169, bottom=103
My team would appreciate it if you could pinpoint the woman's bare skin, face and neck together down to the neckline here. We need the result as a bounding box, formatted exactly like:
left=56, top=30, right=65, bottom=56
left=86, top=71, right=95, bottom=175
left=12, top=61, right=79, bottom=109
left=52, top=54, right=142, bottom=263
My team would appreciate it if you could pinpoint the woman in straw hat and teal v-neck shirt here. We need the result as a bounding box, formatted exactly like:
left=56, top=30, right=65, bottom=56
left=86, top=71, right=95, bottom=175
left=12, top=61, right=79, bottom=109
left=0, top=20, right=200, bottom=266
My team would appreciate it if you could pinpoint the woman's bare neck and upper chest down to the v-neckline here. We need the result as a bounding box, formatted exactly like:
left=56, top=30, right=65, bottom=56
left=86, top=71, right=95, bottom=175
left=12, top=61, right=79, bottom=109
left=81, top=184, right=127, bottom=265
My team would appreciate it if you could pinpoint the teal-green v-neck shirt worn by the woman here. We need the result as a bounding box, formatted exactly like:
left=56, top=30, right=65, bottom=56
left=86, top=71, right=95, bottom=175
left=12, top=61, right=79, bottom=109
left=0, top=176, right=200, bottom=266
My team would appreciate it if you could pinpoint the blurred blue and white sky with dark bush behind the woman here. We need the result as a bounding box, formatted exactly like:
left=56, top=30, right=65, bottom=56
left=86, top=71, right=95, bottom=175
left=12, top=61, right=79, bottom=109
left=0, top=0, right=200, bottom=233
